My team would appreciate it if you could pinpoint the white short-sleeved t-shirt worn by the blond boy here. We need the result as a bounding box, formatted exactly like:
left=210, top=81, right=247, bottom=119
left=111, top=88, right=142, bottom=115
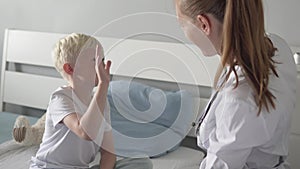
left=30, top=87, right=111, bottom=169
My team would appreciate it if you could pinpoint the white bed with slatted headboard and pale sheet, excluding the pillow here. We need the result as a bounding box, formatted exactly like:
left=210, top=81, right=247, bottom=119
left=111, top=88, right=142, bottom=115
left=0, top=29, right=300, bottom=169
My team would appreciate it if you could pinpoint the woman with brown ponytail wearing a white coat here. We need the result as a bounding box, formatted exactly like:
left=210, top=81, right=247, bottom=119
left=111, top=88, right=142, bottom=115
left=176, top=0, right=296, bottom=169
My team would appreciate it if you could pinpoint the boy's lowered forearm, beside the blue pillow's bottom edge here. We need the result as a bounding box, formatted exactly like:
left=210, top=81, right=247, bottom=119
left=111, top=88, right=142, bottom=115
left=100, top=130, right=116, bottom=169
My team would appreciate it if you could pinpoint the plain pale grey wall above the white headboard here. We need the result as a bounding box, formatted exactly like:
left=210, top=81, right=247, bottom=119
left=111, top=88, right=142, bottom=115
left=0, top=0, right=300, bottom=80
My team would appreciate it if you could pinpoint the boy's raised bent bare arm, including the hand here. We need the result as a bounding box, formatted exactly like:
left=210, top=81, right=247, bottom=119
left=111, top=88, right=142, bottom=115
left=63, top=51, right=111, bottom=140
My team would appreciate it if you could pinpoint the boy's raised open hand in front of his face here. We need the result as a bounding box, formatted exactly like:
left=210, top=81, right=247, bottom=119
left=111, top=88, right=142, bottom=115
left=95, top=45, right=111, bottom=85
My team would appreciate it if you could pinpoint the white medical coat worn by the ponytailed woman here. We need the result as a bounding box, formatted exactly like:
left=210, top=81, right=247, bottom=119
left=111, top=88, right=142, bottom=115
left=197, top=35, right=297, bottom=169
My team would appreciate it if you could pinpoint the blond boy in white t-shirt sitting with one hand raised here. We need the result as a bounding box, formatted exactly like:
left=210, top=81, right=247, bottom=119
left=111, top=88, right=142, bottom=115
left=30, top=33, right=152, bottom=169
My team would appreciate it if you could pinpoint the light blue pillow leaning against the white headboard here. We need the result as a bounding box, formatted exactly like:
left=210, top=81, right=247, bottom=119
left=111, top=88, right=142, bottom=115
left=108, top=81, right=194, bottom=157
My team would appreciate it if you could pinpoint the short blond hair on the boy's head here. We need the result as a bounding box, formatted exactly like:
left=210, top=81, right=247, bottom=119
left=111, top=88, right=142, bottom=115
left=52, top=33, right=102, bottom=79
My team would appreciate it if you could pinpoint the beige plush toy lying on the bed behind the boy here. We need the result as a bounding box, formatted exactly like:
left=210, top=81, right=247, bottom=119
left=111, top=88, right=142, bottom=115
left=12, top=114, right=46, bottom=146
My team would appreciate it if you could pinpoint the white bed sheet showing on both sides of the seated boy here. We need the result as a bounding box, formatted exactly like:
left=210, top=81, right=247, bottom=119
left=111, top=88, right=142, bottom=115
left=0, top=140, right=204, bottom=169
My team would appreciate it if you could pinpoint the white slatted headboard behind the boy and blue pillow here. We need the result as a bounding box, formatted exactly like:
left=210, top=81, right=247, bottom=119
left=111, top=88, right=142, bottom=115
left=0, top=29, right=300, bottom=168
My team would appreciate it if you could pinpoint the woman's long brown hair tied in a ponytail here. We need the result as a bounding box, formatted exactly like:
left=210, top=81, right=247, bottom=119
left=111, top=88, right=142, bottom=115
left=180, top=0, right=278, bottom=115
